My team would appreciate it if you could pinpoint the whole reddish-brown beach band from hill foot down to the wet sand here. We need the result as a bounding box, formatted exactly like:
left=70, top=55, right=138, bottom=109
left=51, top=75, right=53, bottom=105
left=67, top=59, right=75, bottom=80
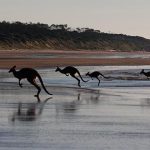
left=0, top=50, right=150, bottom=69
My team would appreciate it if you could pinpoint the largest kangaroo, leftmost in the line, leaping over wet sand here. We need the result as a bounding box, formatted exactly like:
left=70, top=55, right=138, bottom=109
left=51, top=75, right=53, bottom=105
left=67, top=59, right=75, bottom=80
left=9, top=66, right=52, bottom=97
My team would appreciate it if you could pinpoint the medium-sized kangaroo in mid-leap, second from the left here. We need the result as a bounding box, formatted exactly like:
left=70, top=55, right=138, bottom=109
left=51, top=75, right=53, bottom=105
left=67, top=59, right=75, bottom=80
left=55, top=66, right=88, bottom=87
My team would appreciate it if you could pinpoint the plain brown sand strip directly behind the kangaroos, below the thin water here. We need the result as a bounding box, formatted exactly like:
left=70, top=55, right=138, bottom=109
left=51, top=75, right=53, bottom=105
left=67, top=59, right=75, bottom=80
left=0, top=58, right=150, bottom=69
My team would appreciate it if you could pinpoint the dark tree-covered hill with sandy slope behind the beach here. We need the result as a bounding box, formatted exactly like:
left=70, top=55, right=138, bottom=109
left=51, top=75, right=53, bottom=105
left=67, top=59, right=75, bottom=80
left=0, top=21, right=150, bottom=51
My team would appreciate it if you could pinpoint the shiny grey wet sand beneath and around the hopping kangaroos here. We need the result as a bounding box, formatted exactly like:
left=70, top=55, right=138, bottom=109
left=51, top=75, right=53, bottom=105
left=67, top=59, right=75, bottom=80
left=0, top=66, right=150, bottom=150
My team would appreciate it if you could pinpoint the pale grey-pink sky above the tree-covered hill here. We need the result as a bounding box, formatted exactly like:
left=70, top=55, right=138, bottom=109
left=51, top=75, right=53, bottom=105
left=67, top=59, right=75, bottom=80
left=0, top=0, right=150, bottom=39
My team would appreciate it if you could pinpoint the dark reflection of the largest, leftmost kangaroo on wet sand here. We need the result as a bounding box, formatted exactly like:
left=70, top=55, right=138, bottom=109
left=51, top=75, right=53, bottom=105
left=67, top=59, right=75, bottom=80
left=11, top=97, right=52, bottom=122
